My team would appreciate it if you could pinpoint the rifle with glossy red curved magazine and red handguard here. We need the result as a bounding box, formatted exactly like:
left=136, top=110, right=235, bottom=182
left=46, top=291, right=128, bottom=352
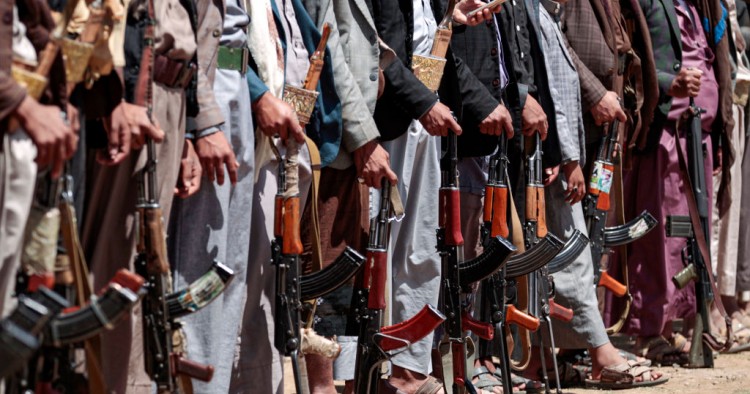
left=352, top=179, right=445, bottom=394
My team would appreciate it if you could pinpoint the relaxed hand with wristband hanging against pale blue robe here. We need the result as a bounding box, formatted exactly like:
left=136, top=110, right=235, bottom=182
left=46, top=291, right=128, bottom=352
left=195, top=131, right=240, bottom=185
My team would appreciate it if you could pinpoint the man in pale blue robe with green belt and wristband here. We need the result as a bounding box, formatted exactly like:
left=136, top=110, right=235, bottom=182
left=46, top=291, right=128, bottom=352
left=168, top=0, right=251, bottom=393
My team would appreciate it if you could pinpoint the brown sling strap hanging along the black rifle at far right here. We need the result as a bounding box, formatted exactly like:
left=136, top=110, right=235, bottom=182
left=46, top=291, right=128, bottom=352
left=675, top=129, right=734, bottom=350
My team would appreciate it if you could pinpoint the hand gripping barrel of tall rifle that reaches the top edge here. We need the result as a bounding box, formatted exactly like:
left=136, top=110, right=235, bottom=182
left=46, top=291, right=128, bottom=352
left=97, top=101, right=164, bottom=165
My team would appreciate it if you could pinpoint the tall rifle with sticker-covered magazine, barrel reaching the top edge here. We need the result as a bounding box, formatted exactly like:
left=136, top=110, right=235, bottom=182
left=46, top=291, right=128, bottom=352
left=135, top=0, right=219, bottom=393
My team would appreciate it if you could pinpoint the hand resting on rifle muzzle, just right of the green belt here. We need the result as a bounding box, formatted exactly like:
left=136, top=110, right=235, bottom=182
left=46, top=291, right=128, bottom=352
left=253, top=93, right=305, bottom=144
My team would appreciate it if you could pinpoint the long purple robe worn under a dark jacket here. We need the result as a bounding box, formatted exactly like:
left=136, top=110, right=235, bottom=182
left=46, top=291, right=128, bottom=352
left=604, top=1, right=719, bottom=337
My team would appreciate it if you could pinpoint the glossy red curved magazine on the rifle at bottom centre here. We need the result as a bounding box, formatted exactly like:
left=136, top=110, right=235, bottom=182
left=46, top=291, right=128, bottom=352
left=378, top=305, right=445, bottom=352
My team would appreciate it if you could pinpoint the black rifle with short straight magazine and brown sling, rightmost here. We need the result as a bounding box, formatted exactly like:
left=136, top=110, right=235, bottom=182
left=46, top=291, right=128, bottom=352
left=666, top=97, right=733, bottom=368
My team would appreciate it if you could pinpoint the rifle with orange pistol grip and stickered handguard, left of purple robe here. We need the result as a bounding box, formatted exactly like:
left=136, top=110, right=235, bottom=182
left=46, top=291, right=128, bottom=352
left=583, top=120, right=657, bottom=297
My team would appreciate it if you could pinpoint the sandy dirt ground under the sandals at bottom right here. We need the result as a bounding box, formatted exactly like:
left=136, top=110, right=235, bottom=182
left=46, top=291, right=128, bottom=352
left=284, top=352, right=750, bottom=394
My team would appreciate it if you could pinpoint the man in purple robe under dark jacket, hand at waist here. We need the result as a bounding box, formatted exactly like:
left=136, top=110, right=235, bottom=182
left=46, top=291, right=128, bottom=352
left=623, top=0, right=733, bottom=363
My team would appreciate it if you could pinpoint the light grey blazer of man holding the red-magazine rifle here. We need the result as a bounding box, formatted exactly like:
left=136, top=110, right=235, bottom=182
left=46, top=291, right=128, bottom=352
left=303, top=0, right=380, bottom=169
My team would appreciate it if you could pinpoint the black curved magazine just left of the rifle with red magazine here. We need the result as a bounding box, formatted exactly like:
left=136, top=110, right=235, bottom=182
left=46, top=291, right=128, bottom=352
left=300, top=246, right=365, bottom=300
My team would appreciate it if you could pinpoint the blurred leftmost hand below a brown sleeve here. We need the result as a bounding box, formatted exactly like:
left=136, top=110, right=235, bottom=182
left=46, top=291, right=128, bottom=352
left=15, top=96, right=78, bottom=178
